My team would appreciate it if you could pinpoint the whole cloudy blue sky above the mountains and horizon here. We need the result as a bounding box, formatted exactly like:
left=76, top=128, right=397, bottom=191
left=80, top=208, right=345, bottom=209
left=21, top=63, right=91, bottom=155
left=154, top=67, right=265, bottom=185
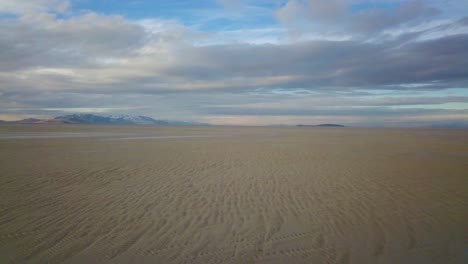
left=0, top=0, right=468, bottom=127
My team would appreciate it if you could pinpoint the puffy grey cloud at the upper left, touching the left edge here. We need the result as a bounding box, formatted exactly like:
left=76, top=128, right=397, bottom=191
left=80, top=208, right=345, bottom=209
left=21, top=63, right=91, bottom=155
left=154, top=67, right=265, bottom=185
left=0, top=13, right=146, bottom=71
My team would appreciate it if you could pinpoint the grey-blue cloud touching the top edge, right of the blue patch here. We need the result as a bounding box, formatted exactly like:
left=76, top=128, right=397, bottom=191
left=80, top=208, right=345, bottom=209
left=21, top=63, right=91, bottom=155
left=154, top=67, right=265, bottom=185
left=276, top=0, right=440, bottom=36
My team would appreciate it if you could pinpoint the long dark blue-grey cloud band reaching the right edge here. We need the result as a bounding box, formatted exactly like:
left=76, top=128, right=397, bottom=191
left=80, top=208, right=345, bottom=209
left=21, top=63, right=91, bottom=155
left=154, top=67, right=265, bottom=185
left=154, top=30, right=468, bottom=90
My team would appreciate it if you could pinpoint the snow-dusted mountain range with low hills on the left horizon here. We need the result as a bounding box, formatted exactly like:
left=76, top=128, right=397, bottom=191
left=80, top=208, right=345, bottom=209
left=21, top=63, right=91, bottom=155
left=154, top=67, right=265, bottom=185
left=0, top=114, right=208, bottom=126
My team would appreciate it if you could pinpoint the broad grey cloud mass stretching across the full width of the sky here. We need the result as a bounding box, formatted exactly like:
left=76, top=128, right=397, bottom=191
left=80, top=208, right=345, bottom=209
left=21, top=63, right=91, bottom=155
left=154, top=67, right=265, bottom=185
left=0, top=13, right=468, bottom=93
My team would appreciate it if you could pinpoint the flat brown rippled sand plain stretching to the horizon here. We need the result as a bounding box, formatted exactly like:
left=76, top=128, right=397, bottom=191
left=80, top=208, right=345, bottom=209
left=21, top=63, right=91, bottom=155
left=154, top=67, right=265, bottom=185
left=0, top=125, right=468, bottom=264
